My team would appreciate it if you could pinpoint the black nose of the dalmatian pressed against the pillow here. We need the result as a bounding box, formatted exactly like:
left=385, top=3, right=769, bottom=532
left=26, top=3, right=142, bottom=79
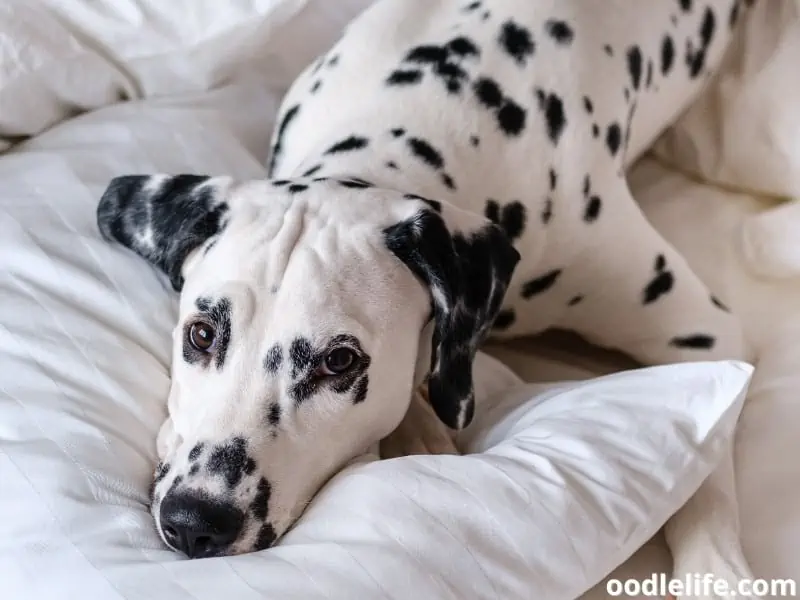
left=160, top=493, right=244, bottom=558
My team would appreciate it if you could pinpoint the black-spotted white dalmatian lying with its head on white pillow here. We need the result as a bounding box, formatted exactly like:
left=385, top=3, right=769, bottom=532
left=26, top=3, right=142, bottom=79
left=98, top=0, right=746, bottom=584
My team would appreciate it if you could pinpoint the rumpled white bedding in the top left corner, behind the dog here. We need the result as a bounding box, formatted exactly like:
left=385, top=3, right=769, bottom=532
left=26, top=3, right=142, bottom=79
left=0, top=0, right=373, bottom=145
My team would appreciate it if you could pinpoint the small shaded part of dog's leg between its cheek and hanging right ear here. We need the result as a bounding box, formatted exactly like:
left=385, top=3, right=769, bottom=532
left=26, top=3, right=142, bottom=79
left=380, top=385, right=459, bottom=458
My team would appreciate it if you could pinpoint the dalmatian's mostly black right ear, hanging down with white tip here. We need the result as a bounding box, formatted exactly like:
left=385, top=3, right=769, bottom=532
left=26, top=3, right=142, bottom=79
left=383, top=206, right=520, bottom=429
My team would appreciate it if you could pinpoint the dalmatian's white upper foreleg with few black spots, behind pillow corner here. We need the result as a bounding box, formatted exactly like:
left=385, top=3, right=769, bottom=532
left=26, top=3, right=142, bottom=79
left=556, top=178, right=746, bottom=365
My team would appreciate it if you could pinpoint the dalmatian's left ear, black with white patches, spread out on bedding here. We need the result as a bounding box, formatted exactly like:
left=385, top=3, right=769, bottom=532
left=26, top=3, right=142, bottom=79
left=97, top=175, right=231, bottom=291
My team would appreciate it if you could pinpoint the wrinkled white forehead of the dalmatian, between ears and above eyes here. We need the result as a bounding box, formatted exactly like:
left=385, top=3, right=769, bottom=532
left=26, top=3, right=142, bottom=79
left=181, top=181, right=427, bottom=338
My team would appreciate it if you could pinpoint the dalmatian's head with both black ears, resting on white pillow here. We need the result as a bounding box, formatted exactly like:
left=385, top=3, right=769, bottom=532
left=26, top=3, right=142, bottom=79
left=97, top=175, right=519, bottom=557
